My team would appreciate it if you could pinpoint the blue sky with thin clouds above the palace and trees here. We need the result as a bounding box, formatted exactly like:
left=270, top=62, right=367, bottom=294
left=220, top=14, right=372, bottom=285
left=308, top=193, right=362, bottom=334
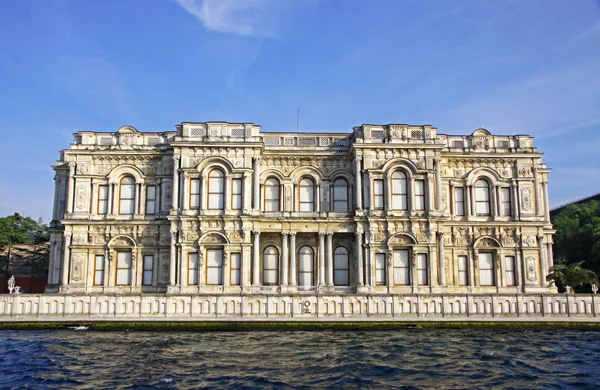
left=0, top=0, right=600, bottom=221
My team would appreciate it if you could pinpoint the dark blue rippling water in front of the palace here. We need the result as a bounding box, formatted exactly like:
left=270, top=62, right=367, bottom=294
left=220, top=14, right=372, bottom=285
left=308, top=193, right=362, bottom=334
left=0, top=328, right=600, bottom=389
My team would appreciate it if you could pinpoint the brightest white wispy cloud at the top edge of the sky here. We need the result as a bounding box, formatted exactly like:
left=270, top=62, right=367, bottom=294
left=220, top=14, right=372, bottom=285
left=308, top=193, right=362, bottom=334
left=176, top=0, right=275, bottom=37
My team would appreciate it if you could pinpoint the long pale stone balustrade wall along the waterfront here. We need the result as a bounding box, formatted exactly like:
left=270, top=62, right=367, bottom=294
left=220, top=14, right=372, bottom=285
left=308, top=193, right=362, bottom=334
left=0, top=293, right=600, bottom=321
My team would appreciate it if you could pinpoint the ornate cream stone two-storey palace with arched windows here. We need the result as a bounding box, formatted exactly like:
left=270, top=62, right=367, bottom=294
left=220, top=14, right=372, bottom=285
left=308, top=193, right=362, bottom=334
left=47, top=122, right=555, bottom=297
